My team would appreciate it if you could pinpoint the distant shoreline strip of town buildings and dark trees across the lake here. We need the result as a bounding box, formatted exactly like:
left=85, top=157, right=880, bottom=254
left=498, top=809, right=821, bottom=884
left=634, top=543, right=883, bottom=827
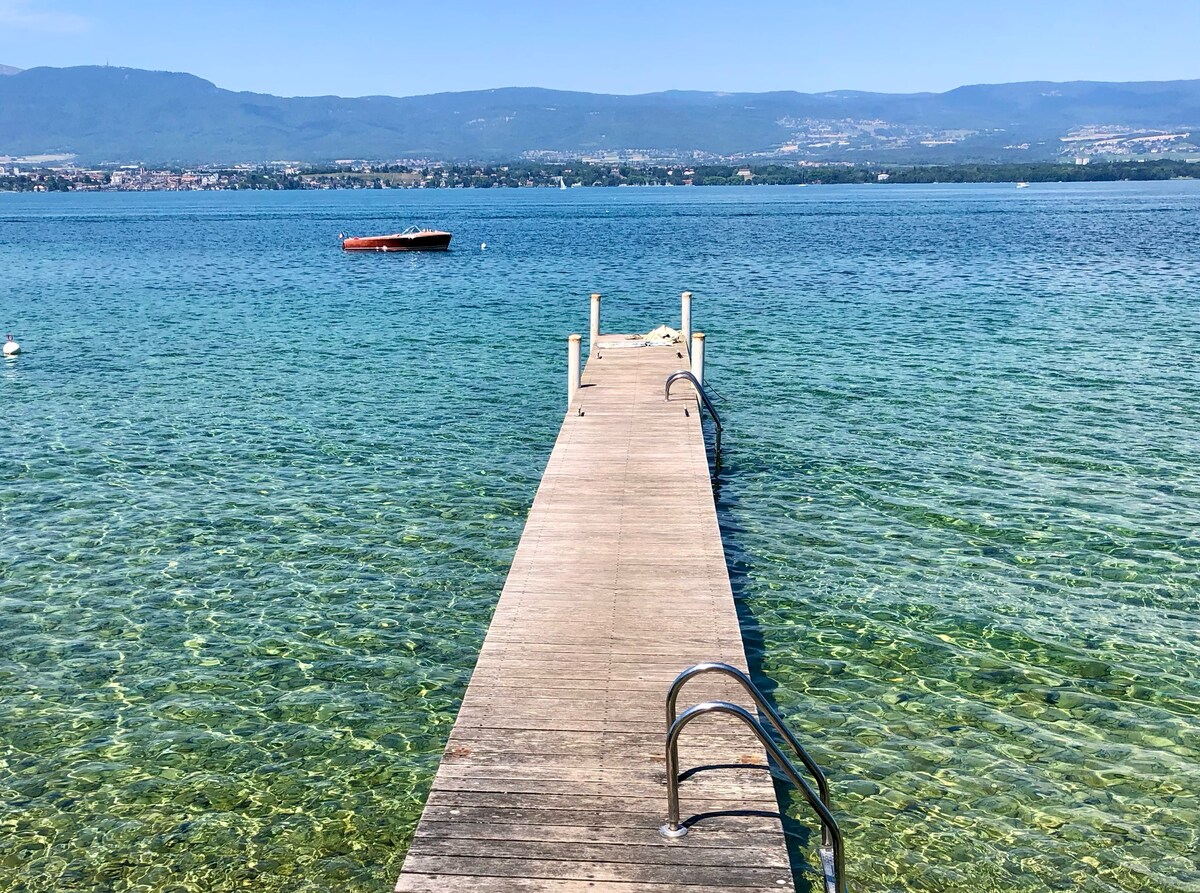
left=0, top=160, right=1200, bottom=192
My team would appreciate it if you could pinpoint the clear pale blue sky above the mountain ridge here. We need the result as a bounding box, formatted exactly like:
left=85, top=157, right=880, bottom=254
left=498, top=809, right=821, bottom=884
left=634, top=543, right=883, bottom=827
left=0, top=0, right=1200, bottom=96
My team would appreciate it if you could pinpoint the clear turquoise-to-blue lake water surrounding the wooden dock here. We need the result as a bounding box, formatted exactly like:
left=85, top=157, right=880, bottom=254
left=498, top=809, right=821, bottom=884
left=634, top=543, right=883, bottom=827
left=0, top=181, right=1200, bottom=893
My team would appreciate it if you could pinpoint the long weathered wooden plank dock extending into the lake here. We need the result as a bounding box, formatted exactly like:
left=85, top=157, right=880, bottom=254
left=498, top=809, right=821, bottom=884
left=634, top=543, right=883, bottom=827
left=396, top=326, right=793, bottom=893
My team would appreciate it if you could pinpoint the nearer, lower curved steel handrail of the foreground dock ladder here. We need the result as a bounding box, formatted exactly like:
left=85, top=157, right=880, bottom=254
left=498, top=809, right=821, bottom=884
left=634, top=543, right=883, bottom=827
left=659, top=701, right=850, bottom=893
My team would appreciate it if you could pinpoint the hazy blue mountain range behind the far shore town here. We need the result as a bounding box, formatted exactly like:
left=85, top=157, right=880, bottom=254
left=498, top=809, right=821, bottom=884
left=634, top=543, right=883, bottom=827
left=0, top=66, right=1200, bottom=163
